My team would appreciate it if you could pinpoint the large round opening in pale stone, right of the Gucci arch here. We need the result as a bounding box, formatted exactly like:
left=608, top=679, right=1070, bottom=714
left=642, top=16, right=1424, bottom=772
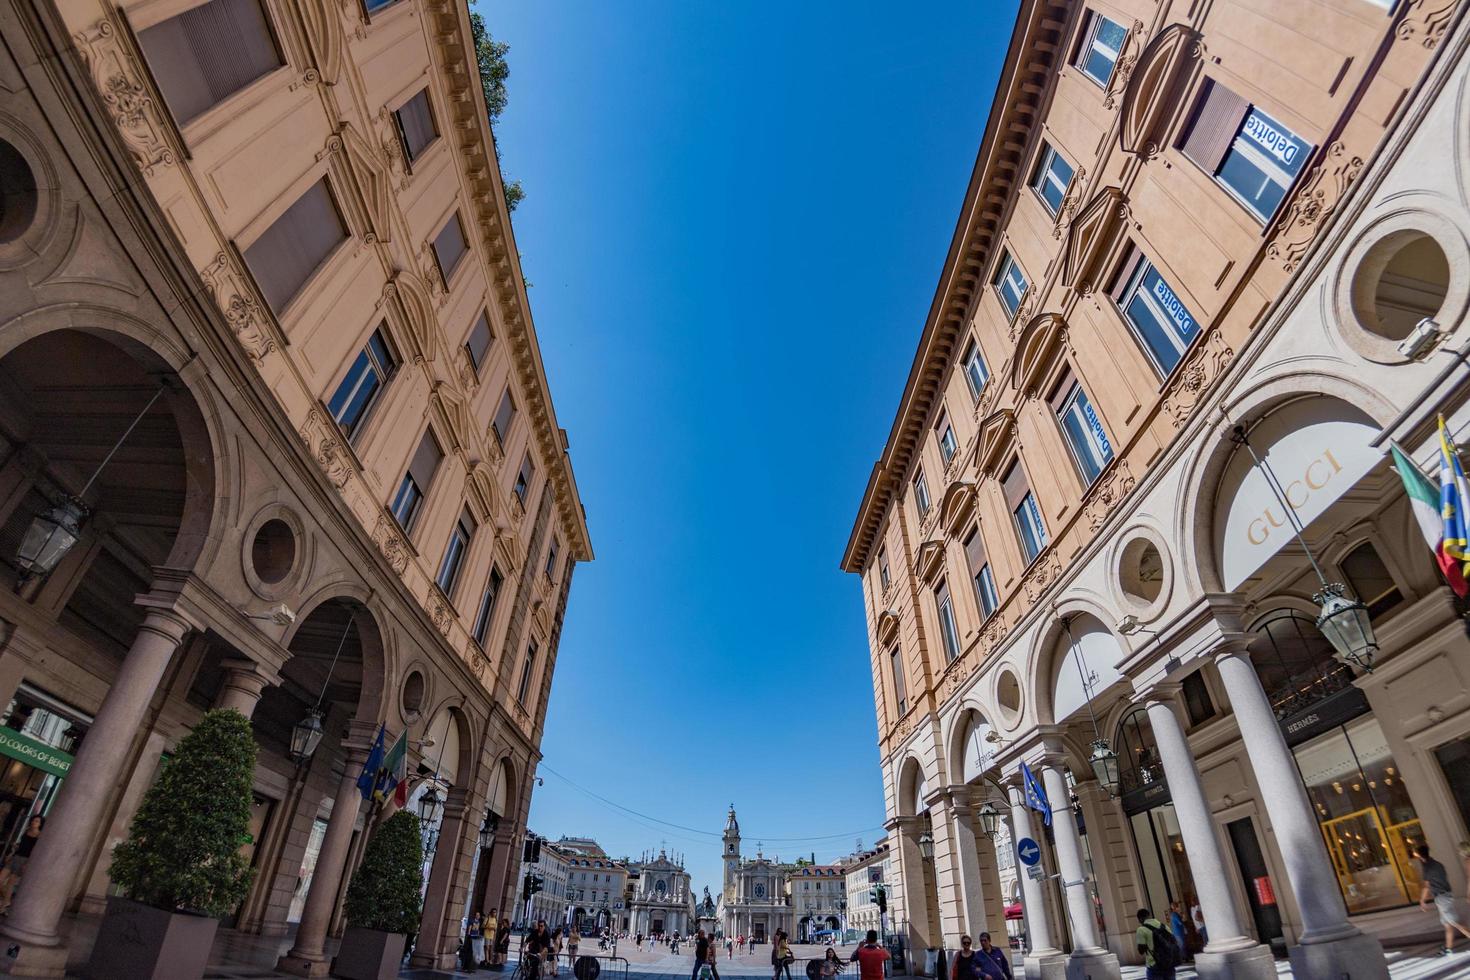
left=1352, top=228, right=1449, bottom=341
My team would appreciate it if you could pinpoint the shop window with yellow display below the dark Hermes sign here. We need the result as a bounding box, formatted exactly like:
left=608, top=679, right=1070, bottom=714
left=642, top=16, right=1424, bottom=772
left=1295, top=717, right=1424, bottom=915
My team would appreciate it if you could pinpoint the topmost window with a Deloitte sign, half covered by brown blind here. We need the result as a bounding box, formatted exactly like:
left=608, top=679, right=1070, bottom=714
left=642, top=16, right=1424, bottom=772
left=1180, top=81, right=1313, bottom=222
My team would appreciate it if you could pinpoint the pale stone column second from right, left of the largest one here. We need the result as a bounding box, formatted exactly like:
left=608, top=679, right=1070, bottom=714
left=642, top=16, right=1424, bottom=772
left=1148, top=702, right=1276, bottom=980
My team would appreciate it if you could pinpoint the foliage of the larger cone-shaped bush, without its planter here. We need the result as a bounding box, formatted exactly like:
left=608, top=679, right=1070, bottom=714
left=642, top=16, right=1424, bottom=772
left=112, top=708, right=256, bottom=918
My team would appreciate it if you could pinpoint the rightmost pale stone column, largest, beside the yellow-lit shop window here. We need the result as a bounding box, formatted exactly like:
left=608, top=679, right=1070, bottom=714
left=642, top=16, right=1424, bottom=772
left=1205, top=642, right=1388, bottom=980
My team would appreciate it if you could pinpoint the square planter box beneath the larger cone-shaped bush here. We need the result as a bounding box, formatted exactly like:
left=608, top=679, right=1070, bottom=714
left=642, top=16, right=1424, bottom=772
left=84, top=896, right=219, bottom=980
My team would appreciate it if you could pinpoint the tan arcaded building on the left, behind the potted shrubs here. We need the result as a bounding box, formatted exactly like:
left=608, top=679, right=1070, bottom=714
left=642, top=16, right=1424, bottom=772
left=0, top=0, right=592, bottom=976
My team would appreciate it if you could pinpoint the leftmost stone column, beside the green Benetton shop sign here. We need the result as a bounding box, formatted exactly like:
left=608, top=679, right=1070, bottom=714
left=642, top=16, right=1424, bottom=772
left=0, top=607, right=191, bottom=977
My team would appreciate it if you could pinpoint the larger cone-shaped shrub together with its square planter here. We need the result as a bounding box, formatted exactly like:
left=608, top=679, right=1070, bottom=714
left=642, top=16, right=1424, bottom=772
left=87, top=708, right=256, bottom=980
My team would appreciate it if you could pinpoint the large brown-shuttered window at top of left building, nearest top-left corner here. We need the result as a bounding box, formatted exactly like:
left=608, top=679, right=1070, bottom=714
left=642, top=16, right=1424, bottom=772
left=138, top=0, right=282, bottom=126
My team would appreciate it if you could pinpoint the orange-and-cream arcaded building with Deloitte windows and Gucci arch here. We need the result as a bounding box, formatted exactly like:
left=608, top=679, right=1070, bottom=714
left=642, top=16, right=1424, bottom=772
left=842, top=0, right=1470, bottom=980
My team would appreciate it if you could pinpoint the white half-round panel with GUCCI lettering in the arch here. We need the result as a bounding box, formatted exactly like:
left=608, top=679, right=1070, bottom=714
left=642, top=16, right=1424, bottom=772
left=1216, top=398, right=1383, bottom=589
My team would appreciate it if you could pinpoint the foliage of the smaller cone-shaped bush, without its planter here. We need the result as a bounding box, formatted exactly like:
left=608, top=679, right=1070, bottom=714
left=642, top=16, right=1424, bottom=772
left=345, top=810, right=423, bottom=934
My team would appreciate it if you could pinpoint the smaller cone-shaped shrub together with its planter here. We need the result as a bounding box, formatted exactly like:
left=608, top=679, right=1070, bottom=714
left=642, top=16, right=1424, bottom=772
left=332, top=810, right=423, bottom=980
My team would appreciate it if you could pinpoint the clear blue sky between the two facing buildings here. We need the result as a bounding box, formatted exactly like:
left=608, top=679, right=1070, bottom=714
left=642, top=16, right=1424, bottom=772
left=475, top=0, right=1016, bottom=892
